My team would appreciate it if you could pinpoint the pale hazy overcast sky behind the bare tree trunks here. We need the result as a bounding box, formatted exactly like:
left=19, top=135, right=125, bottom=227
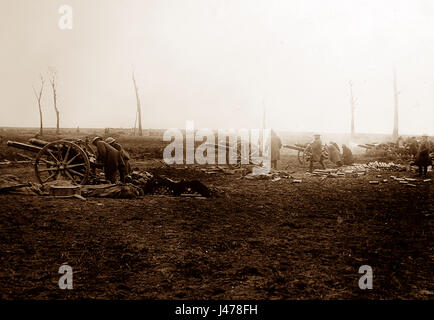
left=0, top=0, right=434, bottom=134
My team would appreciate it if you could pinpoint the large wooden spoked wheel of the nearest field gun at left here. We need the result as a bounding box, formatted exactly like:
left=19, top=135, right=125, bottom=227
left=35, top=141, right=90, bottom=184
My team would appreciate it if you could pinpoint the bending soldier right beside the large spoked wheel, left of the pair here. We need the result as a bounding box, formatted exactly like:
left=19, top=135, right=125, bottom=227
left=92, top=137, right=125, bottom=183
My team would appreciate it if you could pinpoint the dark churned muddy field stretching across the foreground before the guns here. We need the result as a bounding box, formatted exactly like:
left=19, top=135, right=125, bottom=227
left=0, top=131, right=434, bottom=299
